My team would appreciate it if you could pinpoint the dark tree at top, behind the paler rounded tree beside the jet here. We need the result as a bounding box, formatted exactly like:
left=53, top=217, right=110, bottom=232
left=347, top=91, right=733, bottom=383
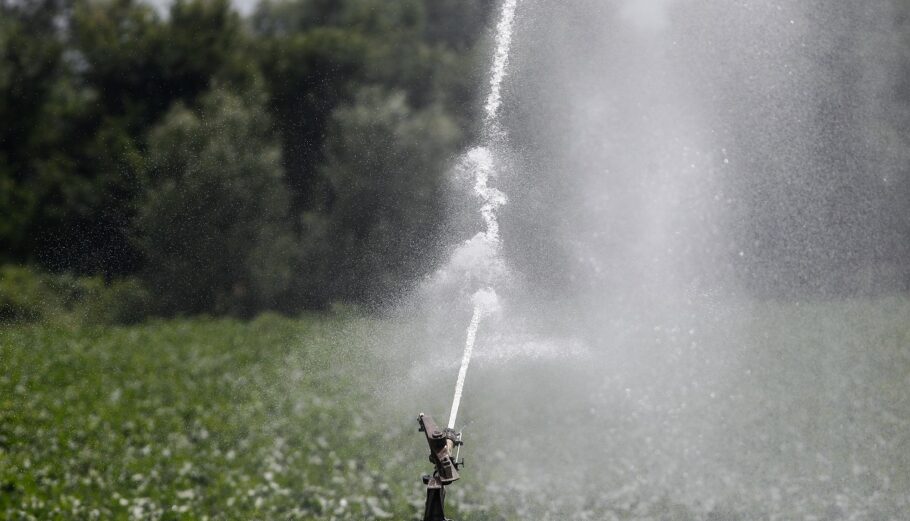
left=252, top=0, right=490, bottom=218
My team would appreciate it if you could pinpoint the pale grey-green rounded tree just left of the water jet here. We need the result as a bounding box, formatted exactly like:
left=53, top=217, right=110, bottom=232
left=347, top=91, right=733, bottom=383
left=301, top=87, right=460, bottom=303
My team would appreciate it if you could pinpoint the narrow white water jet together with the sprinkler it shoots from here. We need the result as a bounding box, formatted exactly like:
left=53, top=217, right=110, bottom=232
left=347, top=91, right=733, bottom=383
left=417, top=0, right=518, bottom=521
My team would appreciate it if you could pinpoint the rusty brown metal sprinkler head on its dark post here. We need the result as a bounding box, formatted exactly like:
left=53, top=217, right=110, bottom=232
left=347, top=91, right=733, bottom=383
left=417, top=413, right=464, bottom=521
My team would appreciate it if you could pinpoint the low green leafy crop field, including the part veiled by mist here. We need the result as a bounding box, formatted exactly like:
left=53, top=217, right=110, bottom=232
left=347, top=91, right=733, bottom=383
left=0, top=299, right=910, bottom=521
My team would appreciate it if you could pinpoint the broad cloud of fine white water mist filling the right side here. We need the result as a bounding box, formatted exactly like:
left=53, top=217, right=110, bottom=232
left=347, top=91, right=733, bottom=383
left=394, top=0, right=910, bottom=521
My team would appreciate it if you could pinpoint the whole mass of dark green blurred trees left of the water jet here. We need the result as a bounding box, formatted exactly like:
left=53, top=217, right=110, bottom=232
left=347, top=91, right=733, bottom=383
left=0, top=0, right=493, bottom=314
